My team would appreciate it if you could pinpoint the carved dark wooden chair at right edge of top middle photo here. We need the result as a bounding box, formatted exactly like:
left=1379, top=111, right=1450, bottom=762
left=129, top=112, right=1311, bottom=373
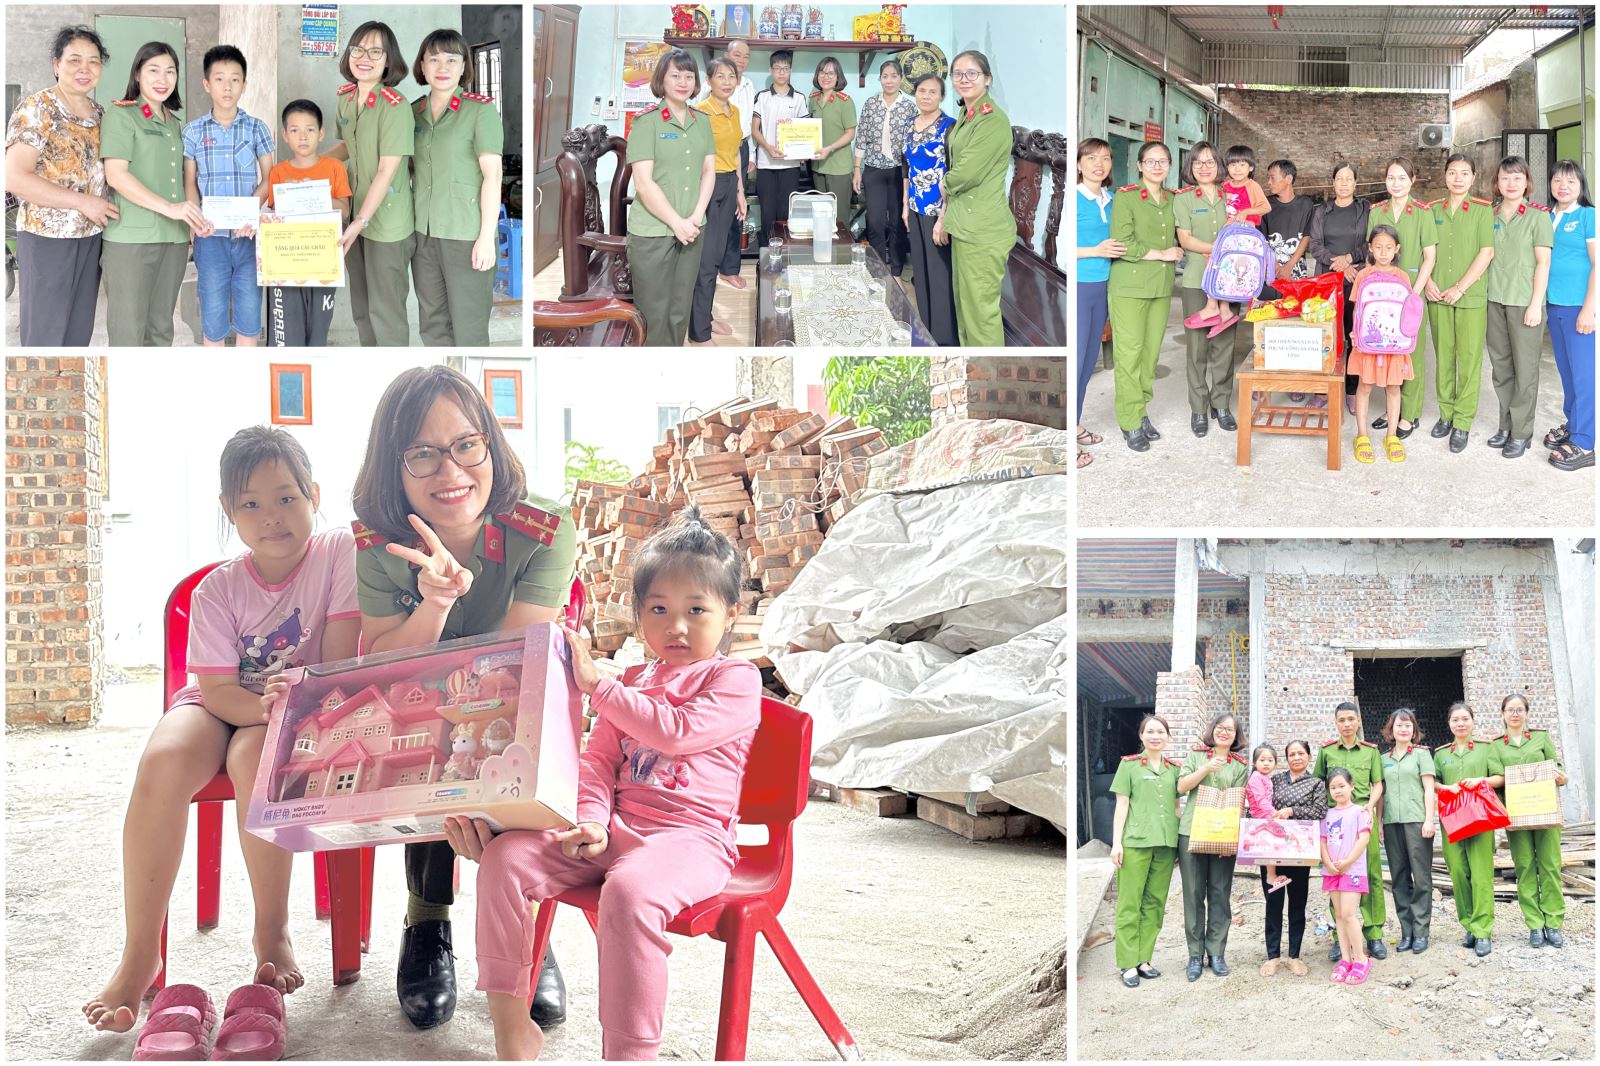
left=1000, top=126, right=1067, bottom=347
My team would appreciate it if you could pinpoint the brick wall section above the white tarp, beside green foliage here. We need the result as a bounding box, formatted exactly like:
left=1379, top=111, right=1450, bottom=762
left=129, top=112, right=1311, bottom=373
left=928, top=355, right=1067, bottom=429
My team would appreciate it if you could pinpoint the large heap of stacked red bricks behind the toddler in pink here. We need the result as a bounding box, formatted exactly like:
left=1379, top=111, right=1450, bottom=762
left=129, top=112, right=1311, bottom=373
left=573, top=397, right=888, bottom=663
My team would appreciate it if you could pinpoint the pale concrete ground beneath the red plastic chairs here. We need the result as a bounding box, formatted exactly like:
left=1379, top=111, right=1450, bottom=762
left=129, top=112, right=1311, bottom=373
left=5, top=679, right=1067, bottom=1060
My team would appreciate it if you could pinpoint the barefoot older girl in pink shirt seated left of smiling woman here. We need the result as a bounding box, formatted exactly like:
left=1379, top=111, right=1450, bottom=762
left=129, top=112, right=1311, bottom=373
left=83, top=426, right=362, bottom=1032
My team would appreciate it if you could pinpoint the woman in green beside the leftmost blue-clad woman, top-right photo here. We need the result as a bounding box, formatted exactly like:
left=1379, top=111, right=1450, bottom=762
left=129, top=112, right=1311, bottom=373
left=1106, top=141, right=1184, bottom=451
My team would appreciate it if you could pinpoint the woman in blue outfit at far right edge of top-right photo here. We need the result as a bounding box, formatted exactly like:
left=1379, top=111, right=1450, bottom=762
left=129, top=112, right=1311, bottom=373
left=1544, top=158, right=1595, bottom=471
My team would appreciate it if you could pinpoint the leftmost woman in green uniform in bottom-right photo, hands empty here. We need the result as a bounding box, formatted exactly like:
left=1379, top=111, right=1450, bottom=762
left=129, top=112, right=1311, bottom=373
left=1110, top=714, right=1178, bottom=988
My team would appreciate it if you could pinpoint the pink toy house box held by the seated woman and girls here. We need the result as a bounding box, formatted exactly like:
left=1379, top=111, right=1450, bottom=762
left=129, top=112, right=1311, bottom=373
left=245, top=623, right=582, bottom=852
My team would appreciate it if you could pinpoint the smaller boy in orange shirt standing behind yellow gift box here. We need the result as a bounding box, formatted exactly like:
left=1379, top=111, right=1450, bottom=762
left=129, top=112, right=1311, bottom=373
left=267, top=99, right=350, bottom=347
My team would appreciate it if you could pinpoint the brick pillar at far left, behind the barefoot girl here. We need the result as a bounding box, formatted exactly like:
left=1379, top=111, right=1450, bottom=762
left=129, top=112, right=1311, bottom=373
left=5, top=359, right=106, bottom=725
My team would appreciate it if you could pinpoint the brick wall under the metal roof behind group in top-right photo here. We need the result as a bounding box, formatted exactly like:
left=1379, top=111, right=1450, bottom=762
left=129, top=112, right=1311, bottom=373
left=1216, top=88, right=1450, bottom=200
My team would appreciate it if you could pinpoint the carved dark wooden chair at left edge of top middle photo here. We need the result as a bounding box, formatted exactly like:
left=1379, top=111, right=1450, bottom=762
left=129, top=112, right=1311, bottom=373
left=555, top=123, right=634, bottom=303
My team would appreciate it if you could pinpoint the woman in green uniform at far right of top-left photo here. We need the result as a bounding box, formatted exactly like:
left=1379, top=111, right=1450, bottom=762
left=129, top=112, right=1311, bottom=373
left=411, top=30, right=506, bottom=347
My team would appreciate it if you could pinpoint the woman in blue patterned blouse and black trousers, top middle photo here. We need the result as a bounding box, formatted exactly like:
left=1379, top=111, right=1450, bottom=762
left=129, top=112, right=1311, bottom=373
left=901, top=74, right=960, bottom=347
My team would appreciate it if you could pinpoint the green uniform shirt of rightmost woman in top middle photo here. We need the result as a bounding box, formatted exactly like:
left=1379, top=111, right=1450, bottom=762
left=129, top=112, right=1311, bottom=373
left=944, top=94, right=1016, bottom=243
